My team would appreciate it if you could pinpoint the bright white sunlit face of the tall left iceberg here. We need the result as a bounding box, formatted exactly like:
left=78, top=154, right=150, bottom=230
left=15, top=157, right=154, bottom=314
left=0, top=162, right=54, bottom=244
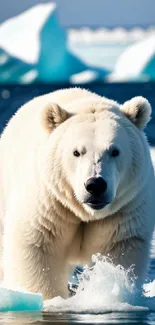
left=0, top=4, right=55, bottom=64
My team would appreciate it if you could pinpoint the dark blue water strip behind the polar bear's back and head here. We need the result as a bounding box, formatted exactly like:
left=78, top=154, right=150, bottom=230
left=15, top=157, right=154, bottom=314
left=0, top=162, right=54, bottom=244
left=0, top=82, right=155, bottom=145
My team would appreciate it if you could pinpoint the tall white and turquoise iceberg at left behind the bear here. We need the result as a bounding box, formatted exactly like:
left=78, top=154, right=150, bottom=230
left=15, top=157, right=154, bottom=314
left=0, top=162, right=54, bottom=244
left=0, top=3, right=107, bottom=83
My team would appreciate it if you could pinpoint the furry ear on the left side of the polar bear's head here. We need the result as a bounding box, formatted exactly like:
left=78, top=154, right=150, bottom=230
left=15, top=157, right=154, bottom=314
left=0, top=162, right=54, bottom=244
left=41, top=103, right=72, bottom=133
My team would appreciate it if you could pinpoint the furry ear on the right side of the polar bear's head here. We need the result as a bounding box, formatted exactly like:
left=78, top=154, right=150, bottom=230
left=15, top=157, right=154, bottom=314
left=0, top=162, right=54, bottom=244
left=120, top=96, right=152, bottom=129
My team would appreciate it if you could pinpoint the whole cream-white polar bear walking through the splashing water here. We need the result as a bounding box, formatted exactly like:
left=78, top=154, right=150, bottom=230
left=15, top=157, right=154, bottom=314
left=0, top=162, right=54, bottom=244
left=0, top=88, right=155, bottom=298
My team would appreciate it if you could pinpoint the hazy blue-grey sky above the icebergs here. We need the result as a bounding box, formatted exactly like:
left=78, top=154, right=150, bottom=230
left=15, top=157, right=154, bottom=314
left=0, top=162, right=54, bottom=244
left=0, top=0, right=155, bottom=28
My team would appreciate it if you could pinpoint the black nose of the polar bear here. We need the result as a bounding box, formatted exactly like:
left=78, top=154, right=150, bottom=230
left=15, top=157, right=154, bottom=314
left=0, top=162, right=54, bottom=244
left=85, top=177, right=107, bottom=196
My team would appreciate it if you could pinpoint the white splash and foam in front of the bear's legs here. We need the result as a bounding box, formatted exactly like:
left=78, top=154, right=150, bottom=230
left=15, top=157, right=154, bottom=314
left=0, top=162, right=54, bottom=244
left=44, top=254, right=155, bottom=313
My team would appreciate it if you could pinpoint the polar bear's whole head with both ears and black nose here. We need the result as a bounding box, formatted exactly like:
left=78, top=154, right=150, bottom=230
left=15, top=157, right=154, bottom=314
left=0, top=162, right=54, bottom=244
left=43, top=97, right=151, bottom=221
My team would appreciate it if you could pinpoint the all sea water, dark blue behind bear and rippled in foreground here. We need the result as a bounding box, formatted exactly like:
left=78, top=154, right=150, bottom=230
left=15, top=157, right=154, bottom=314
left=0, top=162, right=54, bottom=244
left=0, top=82, right=155, bottom=325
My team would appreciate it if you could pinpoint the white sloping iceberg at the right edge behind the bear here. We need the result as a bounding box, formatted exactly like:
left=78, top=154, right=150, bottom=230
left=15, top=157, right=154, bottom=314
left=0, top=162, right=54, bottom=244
left=108, top=35, right=155, bottom=81
